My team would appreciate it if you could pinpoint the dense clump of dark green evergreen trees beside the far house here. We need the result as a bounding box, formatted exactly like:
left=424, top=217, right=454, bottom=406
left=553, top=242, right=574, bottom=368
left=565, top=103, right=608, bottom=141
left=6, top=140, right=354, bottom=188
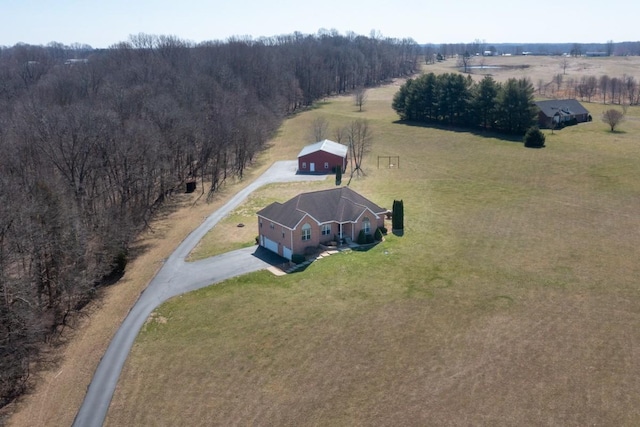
left=392, top=73, right=537, bottom=135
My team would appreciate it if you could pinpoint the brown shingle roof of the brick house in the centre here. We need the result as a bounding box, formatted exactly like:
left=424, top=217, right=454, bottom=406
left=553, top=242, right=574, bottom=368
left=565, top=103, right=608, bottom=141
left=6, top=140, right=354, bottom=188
left=258, top=187, right=387, bottom=229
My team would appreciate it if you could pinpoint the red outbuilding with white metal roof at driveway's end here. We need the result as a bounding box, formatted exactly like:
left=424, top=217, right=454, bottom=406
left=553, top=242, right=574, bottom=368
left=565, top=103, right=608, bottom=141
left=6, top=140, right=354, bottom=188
left=298, top=139, right=349, bottom=174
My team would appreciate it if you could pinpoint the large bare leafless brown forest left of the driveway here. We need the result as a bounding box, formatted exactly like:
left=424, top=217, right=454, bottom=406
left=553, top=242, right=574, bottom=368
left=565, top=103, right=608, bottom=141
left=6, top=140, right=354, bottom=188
left=0, top=32, right=421, bottom=406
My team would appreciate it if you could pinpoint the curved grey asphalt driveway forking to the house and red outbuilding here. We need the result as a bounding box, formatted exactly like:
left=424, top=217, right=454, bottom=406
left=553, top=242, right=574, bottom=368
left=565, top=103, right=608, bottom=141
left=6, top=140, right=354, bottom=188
left=73, top=161, right=326, bottom=427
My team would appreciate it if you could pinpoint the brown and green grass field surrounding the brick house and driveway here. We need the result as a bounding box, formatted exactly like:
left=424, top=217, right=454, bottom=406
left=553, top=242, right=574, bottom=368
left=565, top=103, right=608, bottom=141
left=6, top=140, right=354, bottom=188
left=9, top=57, right=640, bottom=426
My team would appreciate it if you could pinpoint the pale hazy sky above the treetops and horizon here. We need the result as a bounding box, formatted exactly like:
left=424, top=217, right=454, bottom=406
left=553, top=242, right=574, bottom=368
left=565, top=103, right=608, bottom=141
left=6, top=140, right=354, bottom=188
left=0, top=0, right=640, bottom=48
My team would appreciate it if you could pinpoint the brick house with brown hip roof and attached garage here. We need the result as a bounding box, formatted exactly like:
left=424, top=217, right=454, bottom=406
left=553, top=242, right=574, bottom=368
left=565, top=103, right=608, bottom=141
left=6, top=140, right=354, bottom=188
left=258, top=187, right=387, bottom=260
